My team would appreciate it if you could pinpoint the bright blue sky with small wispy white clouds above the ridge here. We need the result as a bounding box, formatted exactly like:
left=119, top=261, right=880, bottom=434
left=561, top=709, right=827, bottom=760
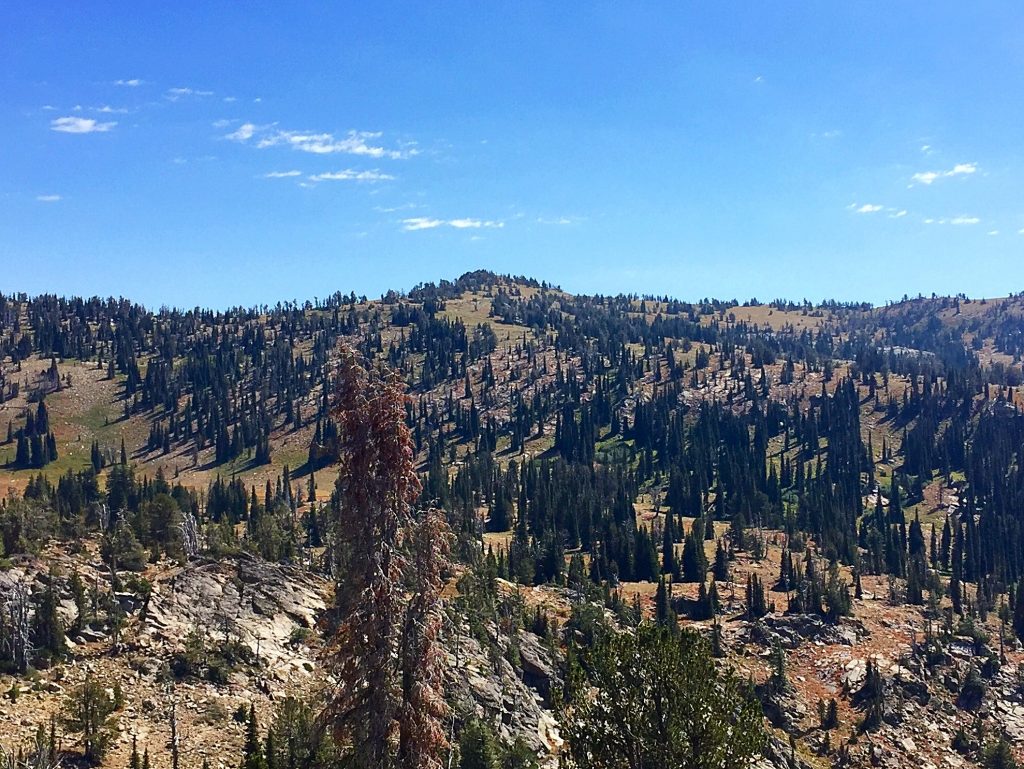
left=0, top=0, right=1024, bottom=307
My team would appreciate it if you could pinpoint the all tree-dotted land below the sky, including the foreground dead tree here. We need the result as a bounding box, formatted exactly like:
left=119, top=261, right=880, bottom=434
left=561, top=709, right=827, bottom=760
left=0, top=271, right=1024, bottom=769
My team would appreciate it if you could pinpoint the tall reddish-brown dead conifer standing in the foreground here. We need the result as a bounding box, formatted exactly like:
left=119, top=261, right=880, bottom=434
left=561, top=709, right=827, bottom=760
left=324, top=349, right=451, bottom=769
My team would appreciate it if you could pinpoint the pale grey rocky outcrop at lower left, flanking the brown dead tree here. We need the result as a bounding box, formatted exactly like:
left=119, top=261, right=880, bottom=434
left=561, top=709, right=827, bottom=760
left=0, top=547, right=560, bottom=769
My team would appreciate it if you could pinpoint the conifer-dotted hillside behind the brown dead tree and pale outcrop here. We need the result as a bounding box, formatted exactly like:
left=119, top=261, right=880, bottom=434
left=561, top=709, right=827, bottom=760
left=0, top=271, right=1024, bottom=769
